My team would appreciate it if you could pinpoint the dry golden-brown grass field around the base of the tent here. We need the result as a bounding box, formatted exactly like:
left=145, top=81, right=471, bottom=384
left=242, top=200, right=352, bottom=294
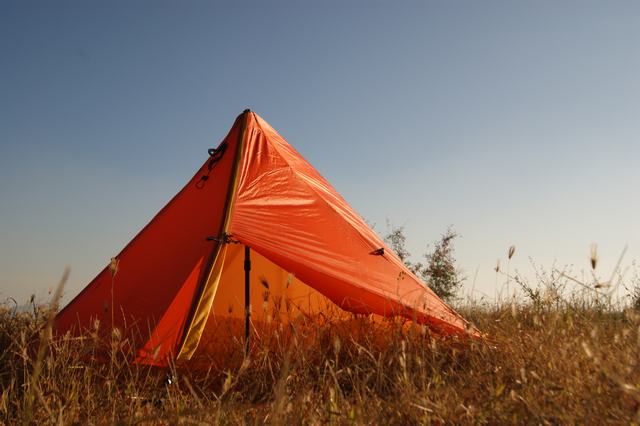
left=0, top=282, right=640, bottom=424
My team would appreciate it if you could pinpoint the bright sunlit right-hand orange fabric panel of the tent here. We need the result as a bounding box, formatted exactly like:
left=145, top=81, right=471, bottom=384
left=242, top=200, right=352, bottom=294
left=230, top=113, right=467, bottom=333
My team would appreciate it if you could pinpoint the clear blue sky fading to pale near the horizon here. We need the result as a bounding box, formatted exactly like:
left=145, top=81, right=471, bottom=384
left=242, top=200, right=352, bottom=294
left=0, top=0, right=640, bottom=302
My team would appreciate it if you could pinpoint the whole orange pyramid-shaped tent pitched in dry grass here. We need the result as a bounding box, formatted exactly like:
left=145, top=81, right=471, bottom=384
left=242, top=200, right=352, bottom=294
left=55, top=110, right=476, bottom=366
